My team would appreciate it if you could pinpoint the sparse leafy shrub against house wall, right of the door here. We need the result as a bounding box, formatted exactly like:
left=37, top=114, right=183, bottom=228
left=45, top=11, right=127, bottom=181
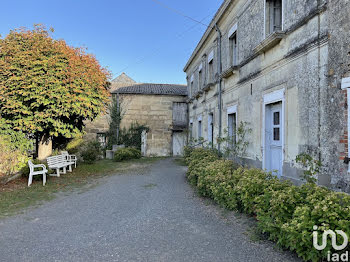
left=295, top=153, right=322, bottom=183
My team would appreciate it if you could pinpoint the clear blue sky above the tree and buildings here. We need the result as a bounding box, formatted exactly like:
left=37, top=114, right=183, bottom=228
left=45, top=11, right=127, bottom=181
left=0, top=0, right=223, bottom=84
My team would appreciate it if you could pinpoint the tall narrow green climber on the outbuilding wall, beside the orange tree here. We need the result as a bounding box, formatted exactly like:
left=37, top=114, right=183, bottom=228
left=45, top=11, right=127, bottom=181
left=107, top=99, right=122, bottom=150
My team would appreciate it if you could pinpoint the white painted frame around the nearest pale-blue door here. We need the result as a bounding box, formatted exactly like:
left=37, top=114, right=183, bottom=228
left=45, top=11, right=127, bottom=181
left=261, top=88, right=286, bottom=176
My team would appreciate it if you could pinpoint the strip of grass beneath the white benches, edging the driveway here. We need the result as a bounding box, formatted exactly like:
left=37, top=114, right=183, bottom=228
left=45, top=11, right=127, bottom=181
left=0, top=158, right=161, bottom=219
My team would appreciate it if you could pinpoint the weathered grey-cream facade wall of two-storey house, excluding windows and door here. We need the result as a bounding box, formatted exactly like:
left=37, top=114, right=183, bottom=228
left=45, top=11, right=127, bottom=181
left=186, top=0, right=350, bottom=190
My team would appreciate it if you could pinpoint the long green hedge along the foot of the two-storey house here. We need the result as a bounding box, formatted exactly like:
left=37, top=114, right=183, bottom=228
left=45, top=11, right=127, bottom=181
left=186, top=148, right=350, bottom=261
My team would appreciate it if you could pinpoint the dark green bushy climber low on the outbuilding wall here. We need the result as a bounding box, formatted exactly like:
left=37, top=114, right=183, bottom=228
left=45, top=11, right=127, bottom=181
left=120, top=122, right=149, bottom=150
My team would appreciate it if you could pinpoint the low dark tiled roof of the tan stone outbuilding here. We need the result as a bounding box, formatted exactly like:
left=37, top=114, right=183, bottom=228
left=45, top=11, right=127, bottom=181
left=111, top=83, right=187, bottom=96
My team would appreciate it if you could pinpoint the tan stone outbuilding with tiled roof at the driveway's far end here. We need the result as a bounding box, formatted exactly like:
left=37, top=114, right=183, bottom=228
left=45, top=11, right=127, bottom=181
left=86, top=73, right=188, bottom=156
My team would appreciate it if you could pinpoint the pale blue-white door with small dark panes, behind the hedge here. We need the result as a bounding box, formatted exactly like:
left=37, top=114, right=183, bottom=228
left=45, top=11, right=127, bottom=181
left=265, top=102, right=283, bottom=177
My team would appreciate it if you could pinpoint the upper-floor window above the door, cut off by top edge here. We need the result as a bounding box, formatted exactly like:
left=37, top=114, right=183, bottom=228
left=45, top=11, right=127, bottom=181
left=265, top=0, right=282, bottom=35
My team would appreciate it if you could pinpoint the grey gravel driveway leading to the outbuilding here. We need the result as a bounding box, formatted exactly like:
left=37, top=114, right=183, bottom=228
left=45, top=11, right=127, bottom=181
left=0, top=159, right=299, bottom=262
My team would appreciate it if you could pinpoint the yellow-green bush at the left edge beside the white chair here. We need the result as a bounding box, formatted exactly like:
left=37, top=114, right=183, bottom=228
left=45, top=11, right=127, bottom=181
left=0, top=119, right=33, bottom=176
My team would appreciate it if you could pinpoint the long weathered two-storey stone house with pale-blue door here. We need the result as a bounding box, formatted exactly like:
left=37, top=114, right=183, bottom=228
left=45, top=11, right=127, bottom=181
left=184, top=0, right=350, bottom=191
